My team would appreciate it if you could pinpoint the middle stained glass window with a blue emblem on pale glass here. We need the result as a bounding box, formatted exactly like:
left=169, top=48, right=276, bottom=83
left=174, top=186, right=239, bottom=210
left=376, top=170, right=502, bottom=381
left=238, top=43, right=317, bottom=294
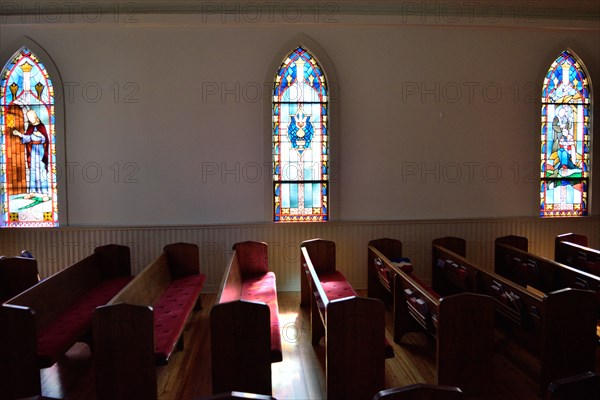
left=272, top=47, right=330, bottom=222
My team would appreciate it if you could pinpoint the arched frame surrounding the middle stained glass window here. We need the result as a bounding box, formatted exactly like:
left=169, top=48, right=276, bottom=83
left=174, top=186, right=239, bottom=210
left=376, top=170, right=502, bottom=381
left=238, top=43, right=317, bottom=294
left=264, top=39, right=339, bottom=222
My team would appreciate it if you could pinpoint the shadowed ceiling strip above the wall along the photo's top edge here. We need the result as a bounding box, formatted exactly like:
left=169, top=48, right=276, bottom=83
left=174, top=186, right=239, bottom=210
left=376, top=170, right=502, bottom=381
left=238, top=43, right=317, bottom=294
left=0, top=0, right=600, bottom=21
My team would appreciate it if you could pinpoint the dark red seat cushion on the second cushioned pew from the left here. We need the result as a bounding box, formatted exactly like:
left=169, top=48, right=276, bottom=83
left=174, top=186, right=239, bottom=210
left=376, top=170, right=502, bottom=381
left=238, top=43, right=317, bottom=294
left=153, top=274, right=206, bottom=364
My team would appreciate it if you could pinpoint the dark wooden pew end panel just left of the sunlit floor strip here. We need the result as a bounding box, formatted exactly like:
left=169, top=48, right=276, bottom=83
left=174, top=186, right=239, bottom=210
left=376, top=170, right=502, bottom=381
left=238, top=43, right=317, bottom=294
left=210, top=300, right=272, bottom=395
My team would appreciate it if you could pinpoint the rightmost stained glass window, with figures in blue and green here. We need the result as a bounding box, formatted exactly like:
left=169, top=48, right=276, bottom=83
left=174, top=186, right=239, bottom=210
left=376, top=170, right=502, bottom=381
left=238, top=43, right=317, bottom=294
left=540, top=51, right=591, bottom=217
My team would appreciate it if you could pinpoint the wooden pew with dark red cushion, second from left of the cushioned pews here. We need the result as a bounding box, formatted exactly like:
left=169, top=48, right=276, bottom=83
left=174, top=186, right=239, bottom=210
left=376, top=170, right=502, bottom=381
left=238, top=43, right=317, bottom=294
left=94, top=243, right=206, bottom=400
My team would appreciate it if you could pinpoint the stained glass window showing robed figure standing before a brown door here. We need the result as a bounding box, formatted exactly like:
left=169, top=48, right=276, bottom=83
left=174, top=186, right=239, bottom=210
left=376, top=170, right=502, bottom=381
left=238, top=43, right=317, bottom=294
left=0, top=47, right=58, bottom=227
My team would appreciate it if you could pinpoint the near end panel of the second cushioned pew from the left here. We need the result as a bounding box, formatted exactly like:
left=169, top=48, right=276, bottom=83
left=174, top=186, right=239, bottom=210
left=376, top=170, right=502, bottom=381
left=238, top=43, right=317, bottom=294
left=93, top=303, right=157, bottom=400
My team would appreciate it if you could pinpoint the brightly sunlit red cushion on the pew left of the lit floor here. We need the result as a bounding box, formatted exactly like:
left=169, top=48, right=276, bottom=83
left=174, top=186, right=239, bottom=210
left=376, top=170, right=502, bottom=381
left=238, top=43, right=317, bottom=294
left=240, top=271, right=283, bottom=362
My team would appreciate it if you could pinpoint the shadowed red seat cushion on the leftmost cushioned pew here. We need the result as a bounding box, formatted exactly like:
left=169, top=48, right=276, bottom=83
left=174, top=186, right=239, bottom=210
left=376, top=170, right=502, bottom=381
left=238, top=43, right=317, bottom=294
left=37, top=276, right=133, bottom=367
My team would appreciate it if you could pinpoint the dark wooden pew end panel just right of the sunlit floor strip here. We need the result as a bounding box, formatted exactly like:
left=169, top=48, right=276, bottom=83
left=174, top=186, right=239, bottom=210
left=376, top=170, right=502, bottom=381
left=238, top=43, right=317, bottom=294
left=325, top=297, right=385, bottom=399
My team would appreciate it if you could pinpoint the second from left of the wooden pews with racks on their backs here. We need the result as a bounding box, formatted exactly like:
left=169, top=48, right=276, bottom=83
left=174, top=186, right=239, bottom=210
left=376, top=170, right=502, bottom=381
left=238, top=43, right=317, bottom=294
left=432, top=238, right=596, bottom=392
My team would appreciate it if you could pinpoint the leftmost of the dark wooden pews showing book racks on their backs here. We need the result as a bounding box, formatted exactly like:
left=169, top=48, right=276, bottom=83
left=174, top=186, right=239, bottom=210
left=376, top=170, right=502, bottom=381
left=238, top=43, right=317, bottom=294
left=368, top=241, right=494, bottom=395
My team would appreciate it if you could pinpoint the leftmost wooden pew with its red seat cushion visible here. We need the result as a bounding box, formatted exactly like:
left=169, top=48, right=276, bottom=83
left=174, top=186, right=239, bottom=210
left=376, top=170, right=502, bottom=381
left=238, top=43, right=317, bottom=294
left=0, top=244, right=132, bottom=398
